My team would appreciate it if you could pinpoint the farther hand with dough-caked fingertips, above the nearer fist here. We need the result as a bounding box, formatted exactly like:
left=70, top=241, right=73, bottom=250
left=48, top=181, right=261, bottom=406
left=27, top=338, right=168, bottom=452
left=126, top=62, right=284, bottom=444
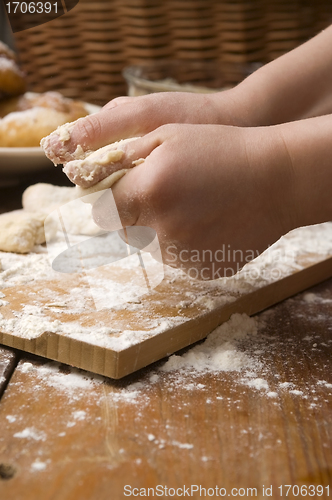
left=44, top=89, right=240, bottom=163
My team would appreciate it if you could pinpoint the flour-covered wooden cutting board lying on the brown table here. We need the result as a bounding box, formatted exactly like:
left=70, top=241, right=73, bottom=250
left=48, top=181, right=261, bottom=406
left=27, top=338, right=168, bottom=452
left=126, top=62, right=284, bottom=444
left=0, top=225, right=332, bottom=379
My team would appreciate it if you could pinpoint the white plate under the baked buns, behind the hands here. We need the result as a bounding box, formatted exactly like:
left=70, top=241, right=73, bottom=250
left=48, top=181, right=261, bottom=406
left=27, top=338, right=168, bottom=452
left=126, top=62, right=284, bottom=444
left=0, top=103, right=101, bottom=178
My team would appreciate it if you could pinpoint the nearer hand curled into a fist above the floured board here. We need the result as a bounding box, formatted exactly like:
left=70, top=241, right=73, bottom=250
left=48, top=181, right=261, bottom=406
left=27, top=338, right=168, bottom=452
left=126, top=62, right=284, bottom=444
left=93, top=124, right=294, bottom=279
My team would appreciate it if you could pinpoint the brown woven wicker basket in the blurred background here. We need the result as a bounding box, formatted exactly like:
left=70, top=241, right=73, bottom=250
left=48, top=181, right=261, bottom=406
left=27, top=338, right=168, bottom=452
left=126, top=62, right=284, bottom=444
left=15, top=0, right=332, bottom=104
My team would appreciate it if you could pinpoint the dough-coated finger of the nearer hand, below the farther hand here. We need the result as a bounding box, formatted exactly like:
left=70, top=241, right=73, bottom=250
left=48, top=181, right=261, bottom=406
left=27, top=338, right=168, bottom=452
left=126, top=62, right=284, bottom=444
left=63, top=134, right=160, bottom=188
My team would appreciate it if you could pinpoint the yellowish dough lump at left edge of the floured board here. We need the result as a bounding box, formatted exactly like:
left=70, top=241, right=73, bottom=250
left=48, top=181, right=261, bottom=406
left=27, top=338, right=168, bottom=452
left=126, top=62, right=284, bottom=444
left=0, top=210, right=45, bottom=253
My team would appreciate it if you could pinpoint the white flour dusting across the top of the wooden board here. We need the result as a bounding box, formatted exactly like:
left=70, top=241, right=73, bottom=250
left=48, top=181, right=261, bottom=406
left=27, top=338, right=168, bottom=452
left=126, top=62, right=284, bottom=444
left=0, top=223, right=332, bottom=356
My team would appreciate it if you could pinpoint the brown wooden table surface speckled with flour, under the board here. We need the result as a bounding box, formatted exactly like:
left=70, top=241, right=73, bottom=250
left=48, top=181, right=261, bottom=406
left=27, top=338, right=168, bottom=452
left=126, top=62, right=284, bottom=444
left=0, top=177, right=332, bottom=500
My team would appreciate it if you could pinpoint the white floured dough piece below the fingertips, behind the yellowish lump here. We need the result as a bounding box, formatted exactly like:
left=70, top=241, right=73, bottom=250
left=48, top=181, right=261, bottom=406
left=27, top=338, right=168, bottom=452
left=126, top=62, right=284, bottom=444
left=22, top=183, right=100, bottom=236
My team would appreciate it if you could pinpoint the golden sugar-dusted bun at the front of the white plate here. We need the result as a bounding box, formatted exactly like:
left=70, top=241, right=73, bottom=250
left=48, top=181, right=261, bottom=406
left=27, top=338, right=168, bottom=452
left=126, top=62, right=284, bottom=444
left=0, top=91, right=88, bottom=147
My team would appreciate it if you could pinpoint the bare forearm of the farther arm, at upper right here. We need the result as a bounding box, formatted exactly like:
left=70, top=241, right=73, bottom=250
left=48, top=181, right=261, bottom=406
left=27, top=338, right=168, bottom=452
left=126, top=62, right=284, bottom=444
left=217, top=26, right=332, bottom=126
